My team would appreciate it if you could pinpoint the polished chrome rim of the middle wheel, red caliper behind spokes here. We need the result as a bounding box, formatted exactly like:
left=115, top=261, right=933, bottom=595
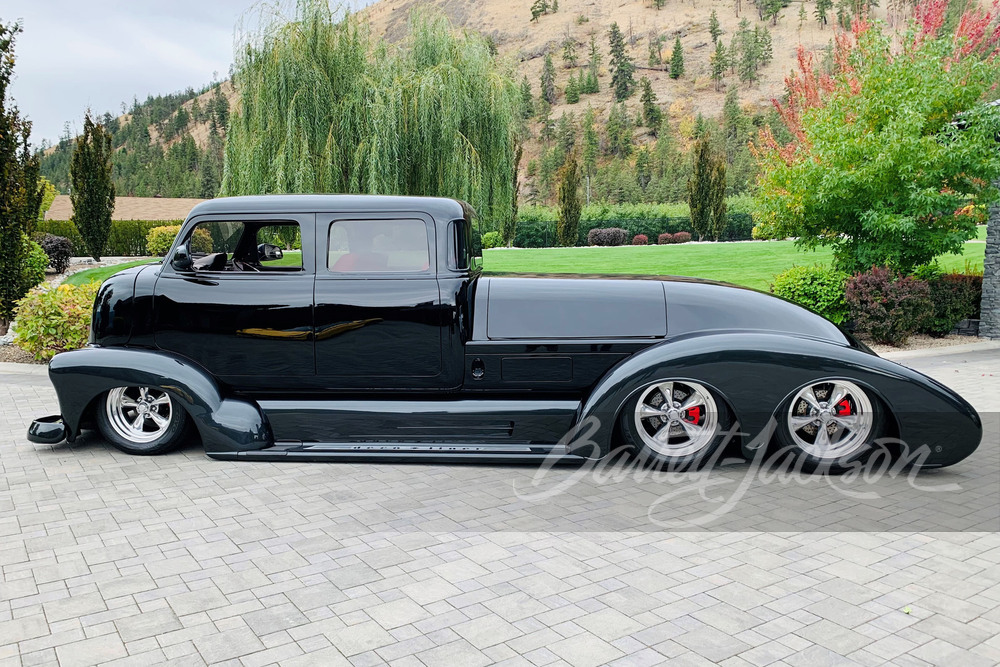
left=634, top=380, right=719, bottom=457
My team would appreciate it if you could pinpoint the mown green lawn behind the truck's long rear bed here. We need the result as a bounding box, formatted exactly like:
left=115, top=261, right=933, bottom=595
left=483, top=241, right=986, bottom=290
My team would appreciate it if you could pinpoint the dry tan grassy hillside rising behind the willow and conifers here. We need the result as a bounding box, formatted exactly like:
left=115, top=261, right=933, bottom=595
left=48, top=0, right=897, bottom=197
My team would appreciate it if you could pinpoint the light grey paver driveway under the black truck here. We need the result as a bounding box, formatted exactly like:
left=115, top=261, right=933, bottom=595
left=0, top=348, right=1000, bottom=666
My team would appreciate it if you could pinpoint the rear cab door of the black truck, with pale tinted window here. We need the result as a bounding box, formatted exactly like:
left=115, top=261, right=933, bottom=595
left=315, top=213, right=450, bottom=389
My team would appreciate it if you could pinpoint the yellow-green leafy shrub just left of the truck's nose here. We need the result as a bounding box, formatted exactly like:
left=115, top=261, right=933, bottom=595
left=14, top=282, right=100, bottom=361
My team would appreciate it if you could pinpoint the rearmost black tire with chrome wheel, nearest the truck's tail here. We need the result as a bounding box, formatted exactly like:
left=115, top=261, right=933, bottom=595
left=771, top=378, right=891, bottom=475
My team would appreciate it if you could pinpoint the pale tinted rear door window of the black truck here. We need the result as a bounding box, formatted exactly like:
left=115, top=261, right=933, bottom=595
left=327, top=220, right=430, bottom=273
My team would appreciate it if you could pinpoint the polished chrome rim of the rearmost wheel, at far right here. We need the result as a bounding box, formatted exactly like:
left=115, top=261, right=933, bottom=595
left=787, top=380, right=874, bottom=460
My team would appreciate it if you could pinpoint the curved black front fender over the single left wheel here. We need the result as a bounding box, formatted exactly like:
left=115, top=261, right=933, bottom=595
left=49, top=347, right=274, bottom=452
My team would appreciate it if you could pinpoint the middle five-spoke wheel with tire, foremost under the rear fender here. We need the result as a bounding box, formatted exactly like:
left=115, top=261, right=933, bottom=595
left=622, top=380, right=728, bottom=469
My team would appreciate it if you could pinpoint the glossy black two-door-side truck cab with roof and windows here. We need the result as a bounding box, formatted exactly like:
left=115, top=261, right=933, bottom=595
left=137, top=195, right=480, bottom=392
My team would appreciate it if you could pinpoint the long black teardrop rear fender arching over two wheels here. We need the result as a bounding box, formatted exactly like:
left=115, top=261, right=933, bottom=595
left=580, top=332, right=982, bottom=466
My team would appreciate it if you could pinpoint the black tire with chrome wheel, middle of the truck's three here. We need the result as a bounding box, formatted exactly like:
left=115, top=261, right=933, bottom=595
left=618, top=380, right=733, bottom=471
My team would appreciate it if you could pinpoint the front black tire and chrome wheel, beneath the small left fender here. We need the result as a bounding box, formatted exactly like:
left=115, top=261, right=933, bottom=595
left=95, top=387, right=190, bottom=456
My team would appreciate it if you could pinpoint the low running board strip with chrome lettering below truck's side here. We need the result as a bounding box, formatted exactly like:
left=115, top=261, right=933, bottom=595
left=205, top=442, right=586, bottom=463
